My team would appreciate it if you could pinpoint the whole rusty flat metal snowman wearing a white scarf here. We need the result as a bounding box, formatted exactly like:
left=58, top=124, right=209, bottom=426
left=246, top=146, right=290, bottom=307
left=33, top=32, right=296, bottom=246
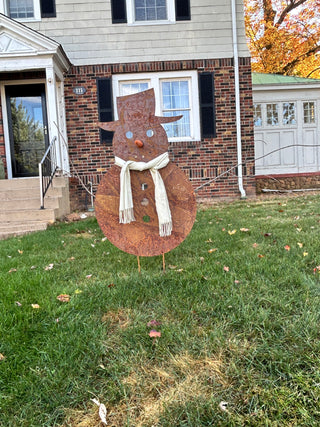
left=95, top=89, right=196, bottom=259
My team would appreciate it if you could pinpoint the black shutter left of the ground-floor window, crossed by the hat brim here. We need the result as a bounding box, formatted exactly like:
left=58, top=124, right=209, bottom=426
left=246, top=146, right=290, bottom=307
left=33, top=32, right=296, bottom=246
left=97, top=77, right=113, bottom=145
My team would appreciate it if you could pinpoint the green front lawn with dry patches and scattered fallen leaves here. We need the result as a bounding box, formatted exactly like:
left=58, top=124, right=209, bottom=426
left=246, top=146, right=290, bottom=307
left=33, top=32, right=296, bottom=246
left=0, top=195, right=320, bottom=427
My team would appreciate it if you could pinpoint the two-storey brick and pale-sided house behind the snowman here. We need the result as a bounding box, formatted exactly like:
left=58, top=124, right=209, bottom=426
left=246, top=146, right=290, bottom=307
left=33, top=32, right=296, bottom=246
left=0, top=0, right=255, bottom=226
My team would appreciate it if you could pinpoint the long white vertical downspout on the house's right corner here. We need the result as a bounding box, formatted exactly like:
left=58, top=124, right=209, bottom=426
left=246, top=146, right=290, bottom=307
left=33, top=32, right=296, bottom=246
left=231, top=0, right=246, bottom=199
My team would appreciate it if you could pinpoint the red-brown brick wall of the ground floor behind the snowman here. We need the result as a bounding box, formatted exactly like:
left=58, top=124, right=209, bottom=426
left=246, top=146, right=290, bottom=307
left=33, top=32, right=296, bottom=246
left=65, top=58, right=255, bottom=208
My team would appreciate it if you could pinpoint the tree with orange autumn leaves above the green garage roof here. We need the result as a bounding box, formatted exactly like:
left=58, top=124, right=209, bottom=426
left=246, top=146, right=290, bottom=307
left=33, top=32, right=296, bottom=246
left=244, top=0, right=320, bottom=78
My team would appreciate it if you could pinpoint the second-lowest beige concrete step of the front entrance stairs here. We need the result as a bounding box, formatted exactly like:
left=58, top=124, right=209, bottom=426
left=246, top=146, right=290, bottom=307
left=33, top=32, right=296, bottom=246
left=0, top=209, right=58, bottom=224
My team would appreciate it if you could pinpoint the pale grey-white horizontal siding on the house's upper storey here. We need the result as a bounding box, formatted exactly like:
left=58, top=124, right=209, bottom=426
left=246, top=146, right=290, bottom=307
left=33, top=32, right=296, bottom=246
left=28, top=0, right=249, bottom=65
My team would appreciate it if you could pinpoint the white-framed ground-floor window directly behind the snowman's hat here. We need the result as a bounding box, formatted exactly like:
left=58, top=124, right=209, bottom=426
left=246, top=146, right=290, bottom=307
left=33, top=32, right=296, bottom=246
left=113, top=71, right=200, bottom=141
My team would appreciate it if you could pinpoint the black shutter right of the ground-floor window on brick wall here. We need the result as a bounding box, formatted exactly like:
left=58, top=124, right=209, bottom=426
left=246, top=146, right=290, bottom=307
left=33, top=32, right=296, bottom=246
left=199, top=73, right=216, bottom=138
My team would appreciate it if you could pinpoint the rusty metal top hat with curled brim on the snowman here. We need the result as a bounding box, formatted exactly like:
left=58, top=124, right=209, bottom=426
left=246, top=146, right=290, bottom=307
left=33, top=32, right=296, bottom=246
left=99, top=89, right=183, bottom=132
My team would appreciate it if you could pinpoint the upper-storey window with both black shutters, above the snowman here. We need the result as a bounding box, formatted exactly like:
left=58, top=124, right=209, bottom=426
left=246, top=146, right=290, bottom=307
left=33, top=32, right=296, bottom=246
left=111, top=0, right=191, bottom=25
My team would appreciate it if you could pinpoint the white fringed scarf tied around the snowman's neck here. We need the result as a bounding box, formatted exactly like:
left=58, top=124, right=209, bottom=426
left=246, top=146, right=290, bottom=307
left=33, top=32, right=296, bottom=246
left=115, top=152, right=172, bottom=237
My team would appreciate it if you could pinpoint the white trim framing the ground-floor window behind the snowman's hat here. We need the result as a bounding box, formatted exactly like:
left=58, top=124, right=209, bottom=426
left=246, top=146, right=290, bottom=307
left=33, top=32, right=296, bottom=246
left=112, top=71, right=201, bottom=142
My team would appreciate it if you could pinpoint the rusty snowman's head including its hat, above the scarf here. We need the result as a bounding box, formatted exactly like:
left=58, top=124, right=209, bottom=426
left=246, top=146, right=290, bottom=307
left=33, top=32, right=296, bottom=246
left=99, top=89, right=182, bottom=162
